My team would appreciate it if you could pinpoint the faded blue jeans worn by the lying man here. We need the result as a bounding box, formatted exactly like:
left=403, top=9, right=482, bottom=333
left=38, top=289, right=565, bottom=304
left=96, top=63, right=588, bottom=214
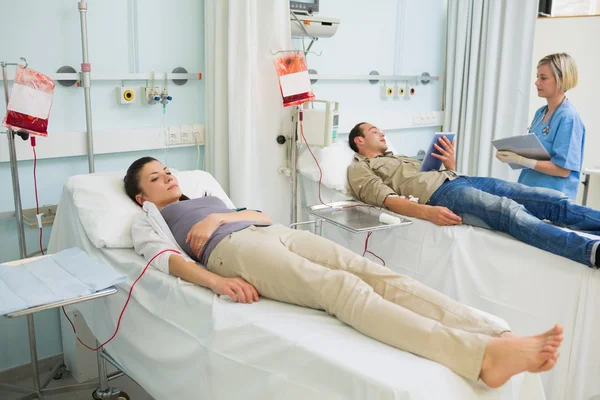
left=428, top=177, right=600, bottom=266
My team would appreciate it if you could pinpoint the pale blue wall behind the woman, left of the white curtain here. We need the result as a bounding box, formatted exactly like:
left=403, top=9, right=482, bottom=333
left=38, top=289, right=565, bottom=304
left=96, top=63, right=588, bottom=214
left=0, top=0, right=204, bottom=370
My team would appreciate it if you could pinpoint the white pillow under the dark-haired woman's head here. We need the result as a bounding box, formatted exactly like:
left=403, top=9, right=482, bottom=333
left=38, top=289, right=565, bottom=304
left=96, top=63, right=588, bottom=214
left=66, top=170, right=234, bottom=248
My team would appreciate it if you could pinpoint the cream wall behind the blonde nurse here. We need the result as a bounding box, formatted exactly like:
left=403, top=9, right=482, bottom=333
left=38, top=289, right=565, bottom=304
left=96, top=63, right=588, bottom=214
left=529, top=16, right=600, bottom=209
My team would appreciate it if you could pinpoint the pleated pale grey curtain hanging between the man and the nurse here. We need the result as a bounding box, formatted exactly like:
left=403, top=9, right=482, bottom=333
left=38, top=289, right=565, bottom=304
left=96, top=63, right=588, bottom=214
left=444, top=0, right=538, bottom=180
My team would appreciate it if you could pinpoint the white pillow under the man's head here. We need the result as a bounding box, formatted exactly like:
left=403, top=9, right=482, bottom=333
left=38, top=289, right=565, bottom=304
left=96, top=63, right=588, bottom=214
left=298, top=137, right=396, bottom=194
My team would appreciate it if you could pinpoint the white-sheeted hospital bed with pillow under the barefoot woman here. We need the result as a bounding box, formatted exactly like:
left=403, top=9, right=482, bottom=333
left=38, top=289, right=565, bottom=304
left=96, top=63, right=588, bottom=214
left=49, top=171, right=545, bottom=400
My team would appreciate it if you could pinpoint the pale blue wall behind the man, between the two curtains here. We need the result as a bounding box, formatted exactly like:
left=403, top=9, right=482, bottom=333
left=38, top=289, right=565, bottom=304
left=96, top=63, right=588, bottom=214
left=295, top=0, right=446, bottom=155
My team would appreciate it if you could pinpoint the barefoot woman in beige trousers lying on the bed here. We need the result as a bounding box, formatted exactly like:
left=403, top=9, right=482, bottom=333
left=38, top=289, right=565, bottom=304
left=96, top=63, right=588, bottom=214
left=124, top=157, right=563, bottom=387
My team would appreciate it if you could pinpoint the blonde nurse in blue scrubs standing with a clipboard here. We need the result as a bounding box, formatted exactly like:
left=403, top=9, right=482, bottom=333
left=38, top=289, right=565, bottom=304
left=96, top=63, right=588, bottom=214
left=496, top=53, right=585, bottom=200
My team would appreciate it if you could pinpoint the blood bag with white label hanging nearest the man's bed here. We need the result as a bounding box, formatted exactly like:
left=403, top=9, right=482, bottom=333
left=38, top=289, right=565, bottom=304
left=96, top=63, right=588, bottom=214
left=275, top=53, right=315, bottom=107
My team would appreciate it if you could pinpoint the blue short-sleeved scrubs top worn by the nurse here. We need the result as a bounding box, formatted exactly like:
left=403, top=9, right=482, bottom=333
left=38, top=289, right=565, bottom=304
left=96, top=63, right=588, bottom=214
left=519, top=100, right=585, bottom=200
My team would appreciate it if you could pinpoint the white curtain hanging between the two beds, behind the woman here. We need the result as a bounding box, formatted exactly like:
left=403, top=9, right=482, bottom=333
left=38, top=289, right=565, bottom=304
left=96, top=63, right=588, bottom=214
left=205, top=0, right=291, bottom=223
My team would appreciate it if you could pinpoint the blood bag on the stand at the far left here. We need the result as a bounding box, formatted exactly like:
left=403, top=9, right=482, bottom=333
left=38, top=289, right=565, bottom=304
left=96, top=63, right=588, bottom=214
left=2, top=65, right=54, bottom=136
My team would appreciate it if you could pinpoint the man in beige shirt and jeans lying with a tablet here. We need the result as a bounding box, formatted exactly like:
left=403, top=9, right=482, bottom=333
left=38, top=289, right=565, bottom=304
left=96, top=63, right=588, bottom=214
left=348, top=122, right=600, bottom=267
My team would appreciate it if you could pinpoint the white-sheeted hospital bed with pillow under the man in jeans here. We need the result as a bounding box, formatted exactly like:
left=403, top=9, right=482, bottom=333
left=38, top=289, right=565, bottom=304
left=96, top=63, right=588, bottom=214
left=299, top=141, right=600, bottom=400
